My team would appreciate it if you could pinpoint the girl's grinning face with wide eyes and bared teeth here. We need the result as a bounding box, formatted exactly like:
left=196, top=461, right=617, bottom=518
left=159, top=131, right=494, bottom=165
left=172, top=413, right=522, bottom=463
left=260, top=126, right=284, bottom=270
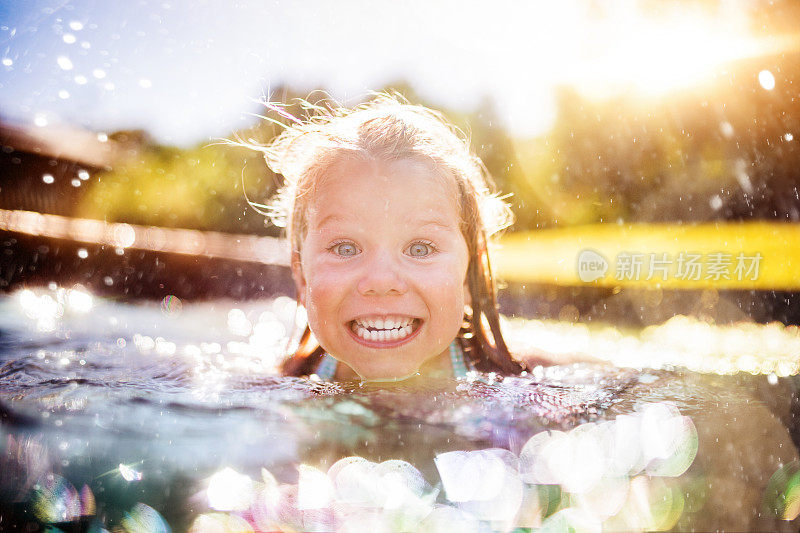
left=292, top=159, right=469, bottom=380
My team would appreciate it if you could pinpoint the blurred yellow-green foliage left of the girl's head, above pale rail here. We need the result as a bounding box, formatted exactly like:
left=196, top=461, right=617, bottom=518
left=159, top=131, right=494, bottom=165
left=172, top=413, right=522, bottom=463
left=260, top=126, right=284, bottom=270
left=79, top=128, right=277, bottom=232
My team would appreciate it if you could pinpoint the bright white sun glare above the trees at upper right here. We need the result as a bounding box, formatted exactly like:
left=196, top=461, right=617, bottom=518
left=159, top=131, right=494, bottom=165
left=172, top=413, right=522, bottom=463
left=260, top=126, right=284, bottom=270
left=553, top=4, right=774, bottom=98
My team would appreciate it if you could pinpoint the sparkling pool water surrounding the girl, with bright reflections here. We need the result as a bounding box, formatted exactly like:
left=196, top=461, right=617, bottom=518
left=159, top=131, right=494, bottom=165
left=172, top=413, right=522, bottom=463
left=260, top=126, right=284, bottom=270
left=0, top=286, right=800, bottom=532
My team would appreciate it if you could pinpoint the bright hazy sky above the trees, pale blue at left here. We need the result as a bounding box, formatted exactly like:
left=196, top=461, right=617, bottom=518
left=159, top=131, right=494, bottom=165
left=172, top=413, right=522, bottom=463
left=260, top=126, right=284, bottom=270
left=0, top=0, right=769, bottom=146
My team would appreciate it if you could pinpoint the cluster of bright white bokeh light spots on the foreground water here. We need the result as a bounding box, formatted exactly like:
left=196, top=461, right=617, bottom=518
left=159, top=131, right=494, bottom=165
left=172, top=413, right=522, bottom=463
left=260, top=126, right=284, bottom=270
left=178, top=403, right=698, bottom=531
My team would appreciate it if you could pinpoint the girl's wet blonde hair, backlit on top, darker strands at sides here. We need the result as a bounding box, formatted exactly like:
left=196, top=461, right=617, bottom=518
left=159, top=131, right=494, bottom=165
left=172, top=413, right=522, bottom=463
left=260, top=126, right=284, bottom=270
left=253, top=94, right=523, bottom=376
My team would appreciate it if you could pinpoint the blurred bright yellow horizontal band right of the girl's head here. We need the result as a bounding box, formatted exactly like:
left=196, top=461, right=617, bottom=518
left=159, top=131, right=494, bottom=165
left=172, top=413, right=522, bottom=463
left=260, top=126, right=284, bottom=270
left=492, top=222, right=800, bottom=290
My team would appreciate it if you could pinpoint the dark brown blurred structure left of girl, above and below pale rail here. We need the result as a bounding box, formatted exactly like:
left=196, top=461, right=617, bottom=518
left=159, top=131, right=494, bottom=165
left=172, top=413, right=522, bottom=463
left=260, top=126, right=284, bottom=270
left=0, top=123, right=292, bottom=300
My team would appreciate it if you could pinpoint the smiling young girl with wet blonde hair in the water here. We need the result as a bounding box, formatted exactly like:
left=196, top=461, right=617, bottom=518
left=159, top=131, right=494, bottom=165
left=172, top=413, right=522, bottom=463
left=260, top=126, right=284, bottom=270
left=261, top=95, right=524, bottom=381
